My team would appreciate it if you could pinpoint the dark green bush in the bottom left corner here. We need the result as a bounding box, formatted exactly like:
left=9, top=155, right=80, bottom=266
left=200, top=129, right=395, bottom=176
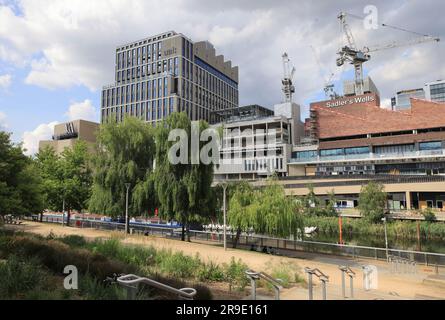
left=0, top=255, right=46, bottom=299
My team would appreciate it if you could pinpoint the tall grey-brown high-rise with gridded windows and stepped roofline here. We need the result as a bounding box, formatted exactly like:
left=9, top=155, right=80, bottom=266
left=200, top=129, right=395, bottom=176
left=101, top=31, right=238, bottom=124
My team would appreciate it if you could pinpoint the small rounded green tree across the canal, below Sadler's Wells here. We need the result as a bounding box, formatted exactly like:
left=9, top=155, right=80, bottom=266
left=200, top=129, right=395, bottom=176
left=358, top=181, right=387, bottom=223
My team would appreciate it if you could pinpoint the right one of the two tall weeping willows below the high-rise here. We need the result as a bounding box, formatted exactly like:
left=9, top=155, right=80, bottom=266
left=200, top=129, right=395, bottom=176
left=155, top=113, right=214, bottom=241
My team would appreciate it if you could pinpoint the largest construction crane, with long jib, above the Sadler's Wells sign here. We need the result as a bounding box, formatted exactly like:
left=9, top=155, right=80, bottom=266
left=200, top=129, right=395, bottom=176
left=337, top=12, right=440, bottom=95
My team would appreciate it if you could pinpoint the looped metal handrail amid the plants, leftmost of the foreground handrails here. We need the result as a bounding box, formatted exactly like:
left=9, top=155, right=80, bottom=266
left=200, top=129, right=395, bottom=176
left=117, top=274, right=196, bottom=300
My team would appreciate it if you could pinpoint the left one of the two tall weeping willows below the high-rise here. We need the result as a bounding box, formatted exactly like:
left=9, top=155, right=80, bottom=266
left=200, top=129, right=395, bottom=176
left=89, top=117, right=156, bottom=228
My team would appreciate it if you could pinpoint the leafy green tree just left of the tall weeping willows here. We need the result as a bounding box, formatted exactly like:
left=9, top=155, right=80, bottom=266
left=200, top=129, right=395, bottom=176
left=36, top=141, right=92, bottom=225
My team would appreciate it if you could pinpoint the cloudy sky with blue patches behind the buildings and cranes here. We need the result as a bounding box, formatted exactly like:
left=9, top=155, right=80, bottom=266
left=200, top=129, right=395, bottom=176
left=0, top=0, right=445, bottom=153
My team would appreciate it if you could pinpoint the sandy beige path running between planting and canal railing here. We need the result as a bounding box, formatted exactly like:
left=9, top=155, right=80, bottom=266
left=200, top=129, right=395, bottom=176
left=6, top=221, right=445, bottom=299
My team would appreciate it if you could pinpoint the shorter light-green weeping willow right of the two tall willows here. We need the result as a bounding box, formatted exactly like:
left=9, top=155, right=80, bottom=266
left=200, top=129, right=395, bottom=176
left=228, top=177, right=303, bottom=246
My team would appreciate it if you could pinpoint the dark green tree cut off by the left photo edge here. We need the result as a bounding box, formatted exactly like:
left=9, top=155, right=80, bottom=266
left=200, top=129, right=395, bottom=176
left=0, top=131, right=44, bottom=215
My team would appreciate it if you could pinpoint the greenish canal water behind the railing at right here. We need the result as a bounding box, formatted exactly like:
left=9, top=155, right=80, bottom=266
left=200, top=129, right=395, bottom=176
left=305, top=233, right=445, bottom=254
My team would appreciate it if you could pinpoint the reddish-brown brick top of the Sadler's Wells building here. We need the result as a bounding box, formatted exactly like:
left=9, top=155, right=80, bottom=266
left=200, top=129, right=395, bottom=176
left=311, top=98, right=445, bottom=139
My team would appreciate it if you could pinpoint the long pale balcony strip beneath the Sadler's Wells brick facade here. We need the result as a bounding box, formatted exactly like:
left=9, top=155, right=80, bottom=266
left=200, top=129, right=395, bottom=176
left=289, top=149, right=445, bottom=163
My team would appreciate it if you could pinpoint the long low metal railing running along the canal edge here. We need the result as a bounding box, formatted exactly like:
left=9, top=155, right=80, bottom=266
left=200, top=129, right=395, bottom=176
left=27, top=217, right=445, bottom=267
